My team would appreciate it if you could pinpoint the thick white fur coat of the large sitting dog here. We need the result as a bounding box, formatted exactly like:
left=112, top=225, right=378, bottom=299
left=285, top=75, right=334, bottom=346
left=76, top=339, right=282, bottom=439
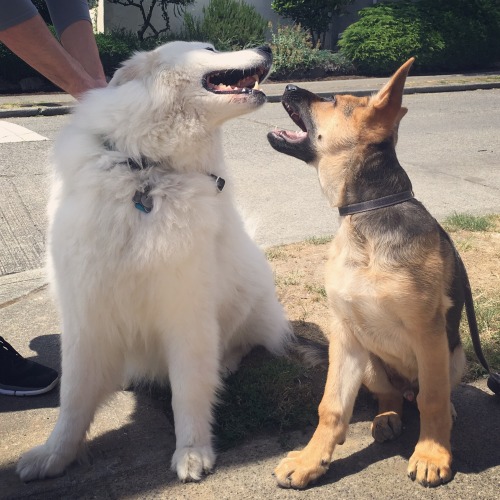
left=17, top=42, right=291, bottom=480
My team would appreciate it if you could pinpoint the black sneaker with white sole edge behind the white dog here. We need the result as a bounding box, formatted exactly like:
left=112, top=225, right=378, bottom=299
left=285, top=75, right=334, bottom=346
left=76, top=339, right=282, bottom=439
left=0, top=337, right=59, bottom=396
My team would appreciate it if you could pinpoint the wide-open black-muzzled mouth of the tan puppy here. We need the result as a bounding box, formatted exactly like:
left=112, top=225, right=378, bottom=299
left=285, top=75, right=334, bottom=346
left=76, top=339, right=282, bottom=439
left=267, top=85, right=322, bottom=163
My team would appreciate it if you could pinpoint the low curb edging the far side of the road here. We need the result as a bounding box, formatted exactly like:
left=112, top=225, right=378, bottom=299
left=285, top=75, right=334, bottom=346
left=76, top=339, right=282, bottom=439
left=0, top=80, right=500, bottom=118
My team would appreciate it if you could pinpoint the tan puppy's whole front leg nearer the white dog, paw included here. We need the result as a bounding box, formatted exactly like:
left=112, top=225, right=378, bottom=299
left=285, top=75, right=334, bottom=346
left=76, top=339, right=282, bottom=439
left=274, top=321, right=369, bottom=489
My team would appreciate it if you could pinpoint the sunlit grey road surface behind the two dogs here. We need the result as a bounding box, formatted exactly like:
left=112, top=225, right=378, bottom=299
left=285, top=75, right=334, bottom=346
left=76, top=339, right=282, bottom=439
left=0, top=89, right=500, bottom=275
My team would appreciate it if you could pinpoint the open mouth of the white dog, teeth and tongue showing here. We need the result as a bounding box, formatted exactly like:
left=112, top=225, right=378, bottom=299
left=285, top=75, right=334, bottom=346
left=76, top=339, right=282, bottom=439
left=203, top=66, right=270, bottom=94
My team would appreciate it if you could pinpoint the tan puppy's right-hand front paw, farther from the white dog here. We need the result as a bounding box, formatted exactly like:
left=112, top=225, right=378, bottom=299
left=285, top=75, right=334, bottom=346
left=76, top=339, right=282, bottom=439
left=408, top=441, right=452, bottom=486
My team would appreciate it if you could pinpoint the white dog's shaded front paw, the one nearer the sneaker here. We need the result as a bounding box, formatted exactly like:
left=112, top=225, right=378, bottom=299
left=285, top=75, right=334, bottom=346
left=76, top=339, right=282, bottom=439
left=16, top=445, right=71, bottom=481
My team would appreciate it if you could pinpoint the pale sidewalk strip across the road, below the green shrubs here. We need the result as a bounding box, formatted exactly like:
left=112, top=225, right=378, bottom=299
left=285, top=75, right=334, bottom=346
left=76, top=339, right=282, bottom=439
left=0, top=72, right=500, bottom=118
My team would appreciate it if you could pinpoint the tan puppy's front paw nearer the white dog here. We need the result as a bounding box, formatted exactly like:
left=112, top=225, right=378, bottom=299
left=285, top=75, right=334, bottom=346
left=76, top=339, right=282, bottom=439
left=274, top=448, right=330, bottom=489
